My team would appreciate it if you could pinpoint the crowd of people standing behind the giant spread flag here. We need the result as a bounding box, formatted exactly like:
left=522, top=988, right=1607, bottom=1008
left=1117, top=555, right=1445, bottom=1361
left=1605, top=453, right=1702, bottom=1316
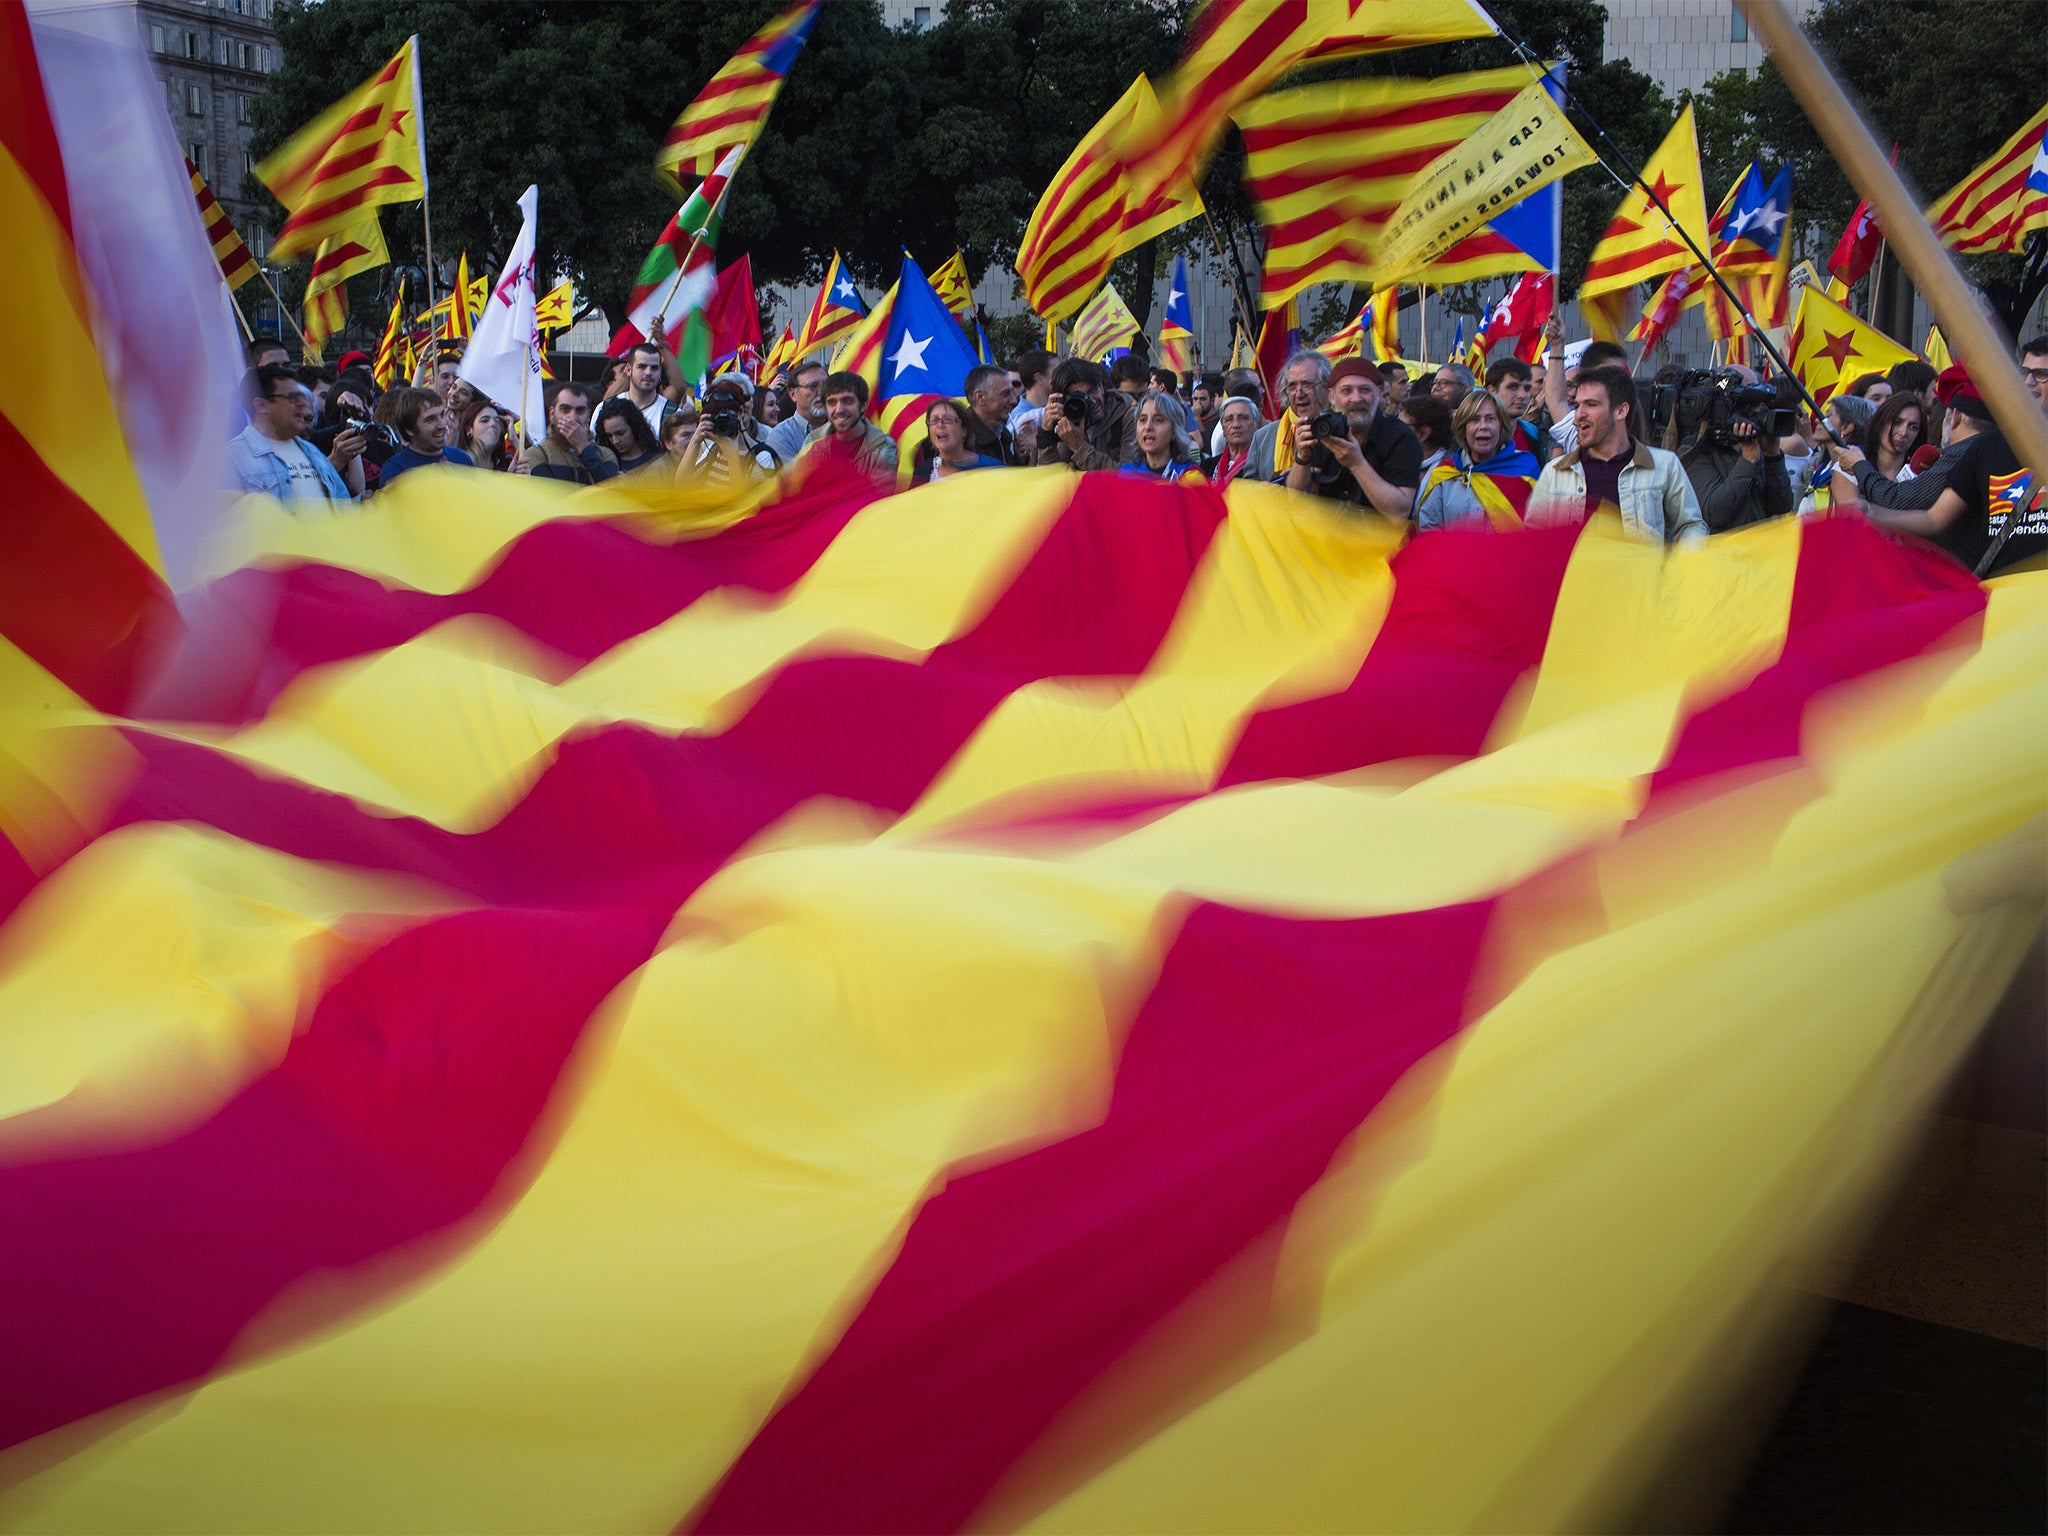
left=231, top=307, right=2048, bottom=573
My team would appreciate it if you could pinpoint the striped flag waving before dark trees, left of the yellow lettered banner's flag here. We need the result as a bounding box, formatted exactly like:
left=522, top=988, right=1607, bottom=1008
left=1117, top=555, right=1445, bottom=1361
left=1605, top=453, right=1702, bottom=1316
left=1016, top=76, right=1202, bottom=322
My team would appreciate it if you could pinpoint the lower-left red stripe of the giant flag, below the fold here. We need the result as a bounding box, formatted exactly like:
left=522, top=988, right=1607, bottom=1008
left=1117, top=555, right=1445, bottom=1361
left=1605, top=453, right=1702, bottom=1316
left=0, top=911, right=666, bottom=1444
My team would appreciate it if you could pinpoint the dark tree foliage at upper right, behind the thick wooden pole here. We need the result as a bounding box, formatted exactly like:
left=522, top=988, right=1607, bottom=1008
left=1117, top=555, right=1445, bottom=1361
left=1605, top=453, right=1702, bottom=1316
left=1698, top=0, right=2048, bottom=328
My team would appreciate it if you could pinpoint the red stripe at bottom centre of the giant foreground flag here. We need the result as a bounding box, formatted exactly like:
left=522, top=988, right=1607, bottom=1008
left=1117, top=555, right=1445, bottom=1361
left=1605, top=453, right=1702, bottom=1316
left=690, top=905, right=1491, bottom=1532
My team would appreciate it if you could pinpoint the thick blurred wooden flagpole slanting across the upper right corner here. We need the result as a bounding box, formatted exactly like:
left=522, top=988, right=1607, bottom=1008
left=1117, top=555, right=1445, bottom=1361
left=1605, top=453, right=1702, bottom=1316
left=1735, top=0, right=2048, bottom=487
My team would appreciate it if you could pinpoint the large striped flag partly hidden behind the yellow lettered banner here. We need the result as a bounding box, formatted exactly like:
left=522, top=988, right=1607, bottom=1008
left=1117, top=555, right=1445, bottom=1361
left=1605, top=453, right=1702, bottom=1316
left=1237, top=66, right=1530, bottom=307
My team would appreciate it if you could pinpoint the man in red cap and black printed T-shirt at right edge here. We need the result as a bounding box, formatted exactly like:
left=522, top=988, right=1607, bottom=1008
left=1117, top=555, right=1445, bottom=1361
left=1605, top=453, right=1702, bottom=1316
left=1858, top=365, right=2048, bottom=575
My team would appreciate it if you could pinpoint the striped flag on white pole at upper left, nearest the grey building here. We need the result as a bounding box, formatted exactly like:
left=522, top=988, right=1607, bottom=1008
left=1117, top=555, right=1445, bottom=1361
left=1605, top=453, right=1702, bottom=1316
left=256, top=37, right=426, bottom=260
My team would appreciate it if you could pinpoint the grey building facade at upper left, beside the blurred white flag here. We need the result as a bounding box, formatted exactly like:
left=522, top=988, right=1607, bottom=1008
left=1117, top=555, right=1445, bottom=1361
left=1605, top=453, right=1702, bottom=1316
left=135, top=0, right=281, bottom=258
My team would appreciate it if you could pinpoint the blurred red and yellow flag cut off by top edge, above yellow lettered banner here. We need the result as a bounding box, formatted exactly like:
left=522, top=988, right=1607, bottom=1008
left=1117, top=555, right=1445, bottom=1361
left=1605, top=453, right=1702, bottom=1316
left=1118, top=0, right=1499, bottom=188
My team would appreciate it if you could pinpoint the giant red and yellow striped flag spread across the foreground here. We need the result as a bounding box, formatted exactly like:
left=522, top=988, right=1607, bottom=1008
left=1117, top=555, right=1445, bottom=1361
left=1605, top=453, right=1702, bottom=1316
left=0, top=450, right=2048, bottom=1532
